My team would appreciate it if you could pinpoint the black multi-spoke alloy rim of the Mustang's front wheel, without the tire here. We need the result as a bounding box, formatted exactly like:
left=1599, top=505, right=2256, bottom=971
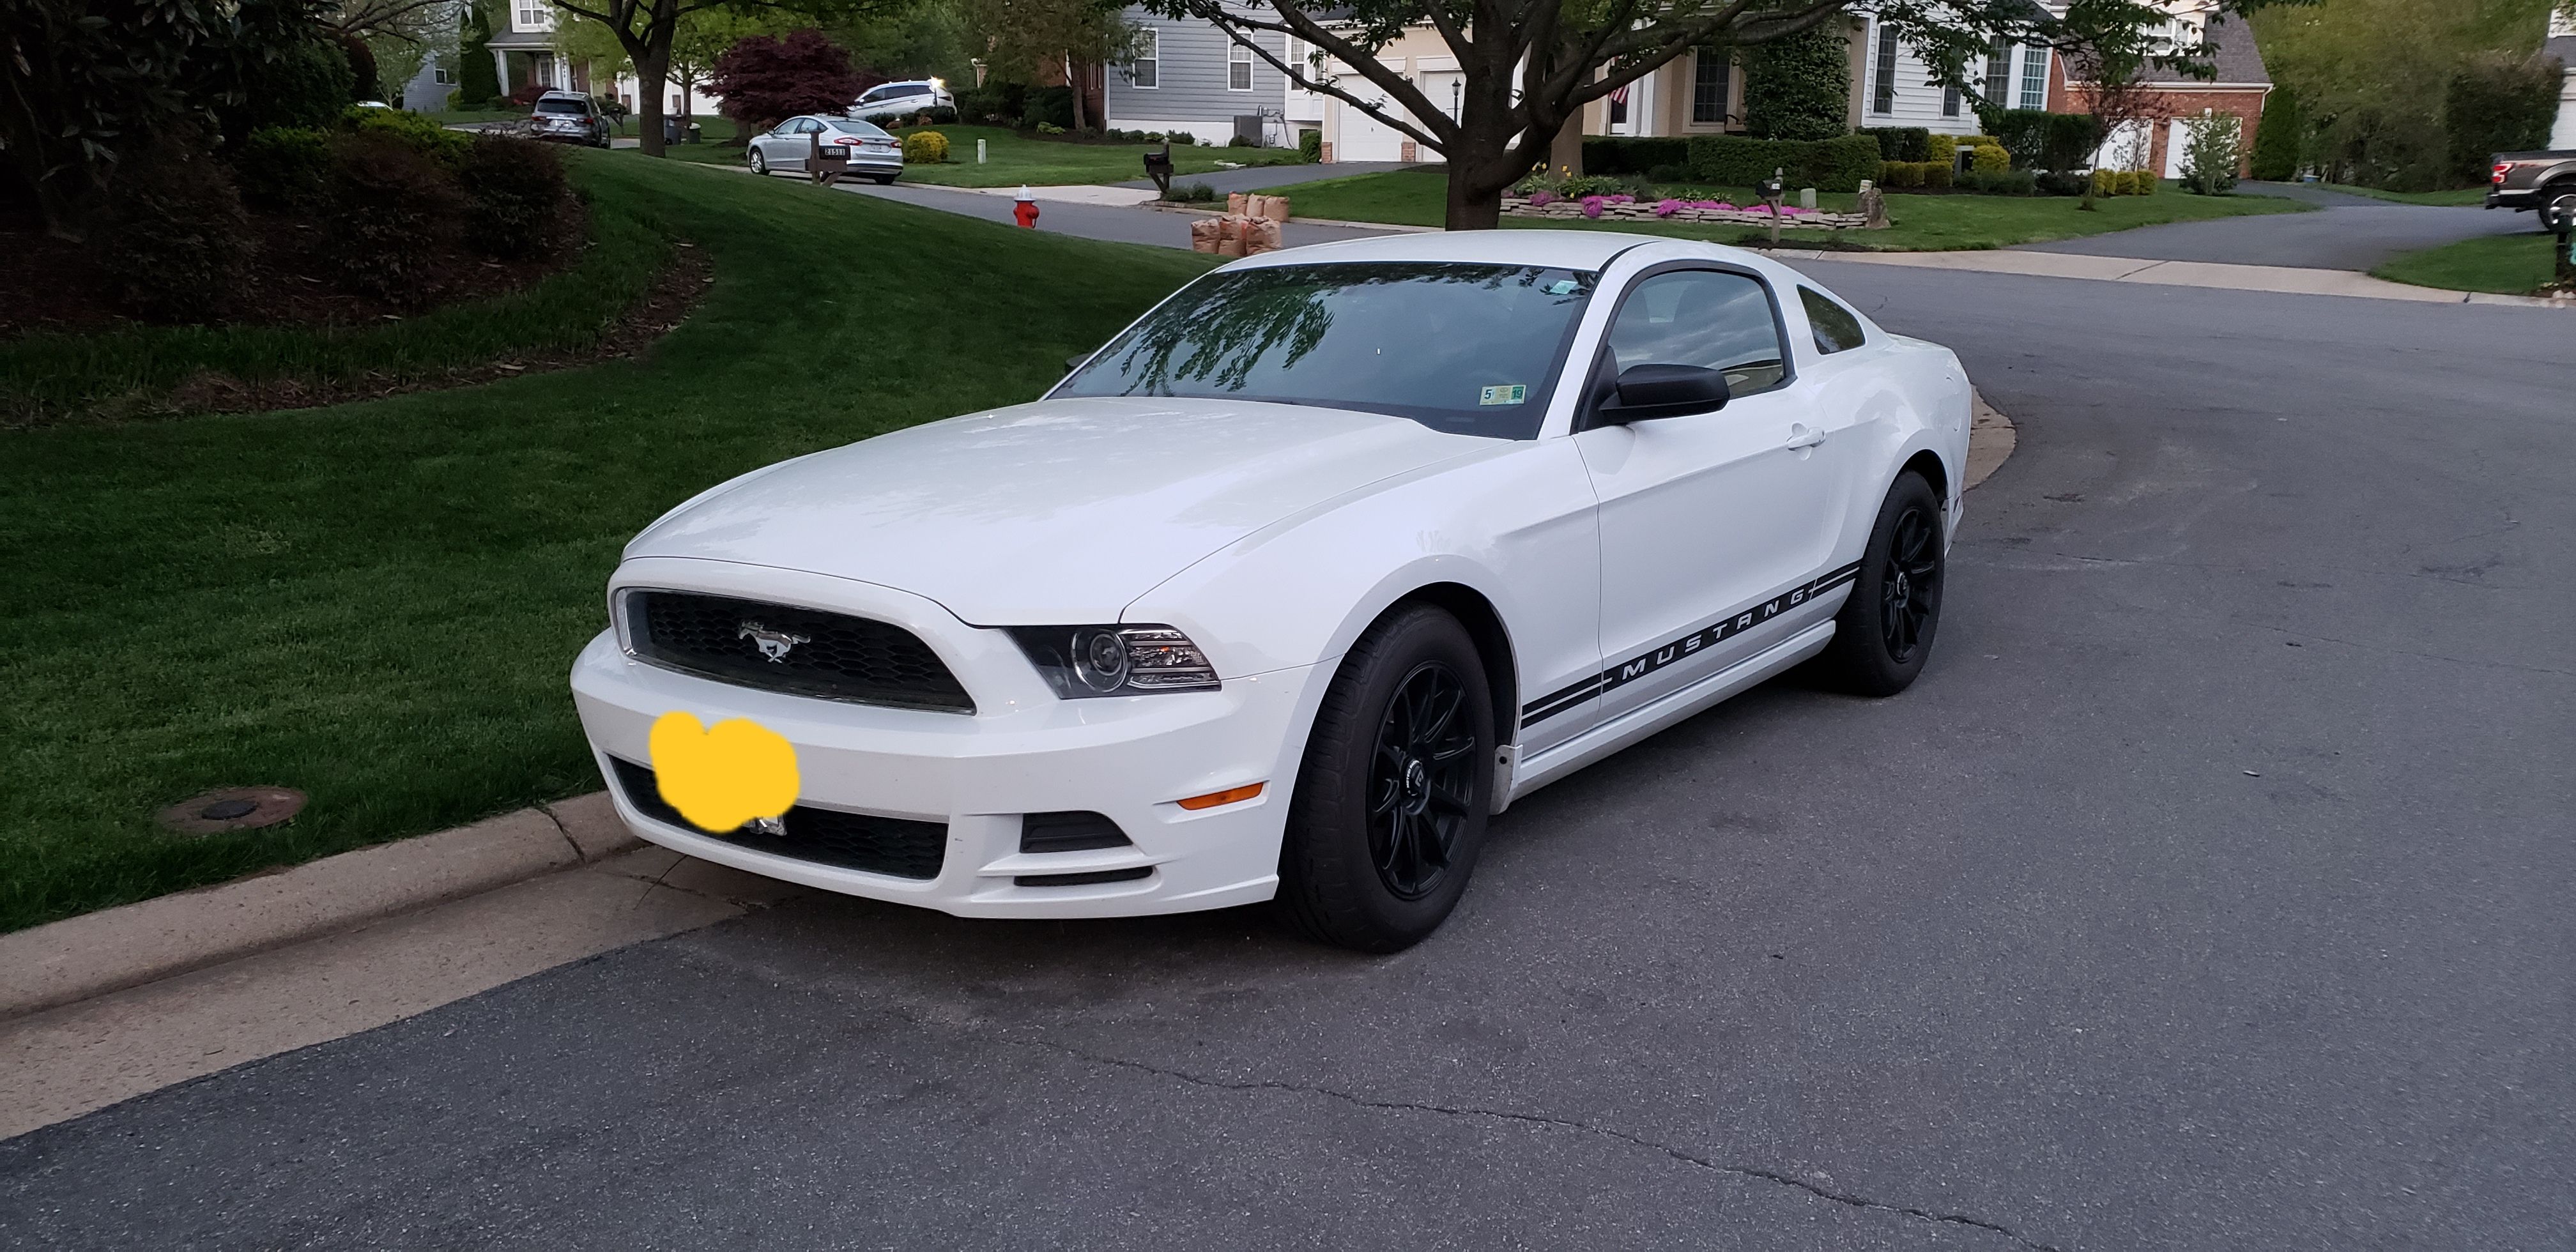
left=1368, top=659, right=1478, bottom=902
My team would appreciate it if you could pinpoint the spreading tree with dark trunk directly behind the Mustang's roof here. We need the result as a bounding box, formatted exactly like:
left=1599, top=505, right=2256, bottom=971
left=1144, top=0, right=2318, bottom=229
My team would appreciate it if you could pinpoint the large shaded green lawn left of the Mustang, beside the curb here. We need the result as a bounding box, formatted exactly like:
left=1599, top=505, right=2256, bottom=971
left=0, top=152, right=1216, bottom=930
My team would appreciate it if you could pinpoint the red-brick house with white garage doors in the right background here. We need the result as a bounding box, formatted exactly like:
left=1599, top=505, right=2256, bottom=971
left=2048, top=0, right=2272, bottom=178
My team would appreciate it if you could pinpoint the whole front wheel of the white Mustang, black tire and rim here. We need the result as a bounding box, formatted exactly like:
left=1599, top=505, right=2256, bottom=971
left=1278, top=606, right=1494, bottom=953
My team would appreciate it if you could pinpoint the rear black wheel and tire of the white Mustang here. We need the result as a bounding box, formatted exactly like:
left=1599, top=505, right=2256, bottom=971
left=1819, top=469, right=1950, bottom=696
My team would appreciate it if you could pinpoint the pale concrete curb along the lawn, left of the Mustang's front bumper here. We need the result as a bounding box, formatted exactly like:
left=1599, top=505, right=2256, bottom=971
left=0, top=791, right=641, bottom=1020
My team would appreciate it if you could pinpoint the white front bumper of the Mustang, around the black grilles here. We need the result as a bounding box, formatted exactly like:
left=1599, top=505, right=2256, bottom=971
left=572, top=559, right=1319, bottom=917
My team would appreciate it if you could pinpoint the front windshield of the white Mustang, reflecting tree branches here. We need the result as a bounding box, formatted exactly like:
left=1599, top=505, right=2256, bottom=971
left=1054, top=260, right=1597, bottom=438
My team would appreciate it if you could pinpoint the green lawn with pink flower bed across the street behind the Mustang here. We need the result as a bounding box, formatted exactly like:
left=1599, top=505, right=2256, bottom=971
left=1273, top=165, right=2308, bottom=252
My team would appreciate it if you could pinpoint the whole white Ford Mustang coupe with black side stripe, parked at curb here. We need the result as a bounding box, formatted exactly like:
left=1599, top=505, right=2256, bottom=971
left=572, top=229, right=1970, bottom=950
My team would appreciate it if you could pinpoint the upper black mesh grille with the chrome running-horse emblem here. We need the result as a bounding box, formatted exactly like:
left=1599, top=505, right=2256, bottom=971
left=626, top=590, right=974, bottom=714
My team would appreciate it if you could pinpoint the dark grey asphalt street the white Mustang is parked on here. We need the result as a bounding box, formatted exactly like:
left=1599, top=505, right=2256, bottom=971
left=0, top=263, right=2576, bottom=1249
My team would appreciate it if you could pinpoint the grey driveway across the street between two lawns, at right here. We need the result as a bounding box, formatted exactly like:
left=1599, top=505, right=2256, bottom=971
left=2017, top=183, right=2540, bottom=270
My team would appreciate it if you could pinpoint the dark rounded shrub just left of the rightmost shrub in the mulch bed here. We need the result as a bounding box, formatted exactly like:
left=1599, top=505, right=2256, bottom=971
left=322, top=134, right=464, bottom=307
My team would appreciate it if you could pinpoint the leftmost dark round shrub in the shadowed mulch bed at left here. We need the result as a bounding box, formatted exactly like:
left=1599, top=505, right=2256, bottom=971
left=90, top=139, right=252, bottom=322
